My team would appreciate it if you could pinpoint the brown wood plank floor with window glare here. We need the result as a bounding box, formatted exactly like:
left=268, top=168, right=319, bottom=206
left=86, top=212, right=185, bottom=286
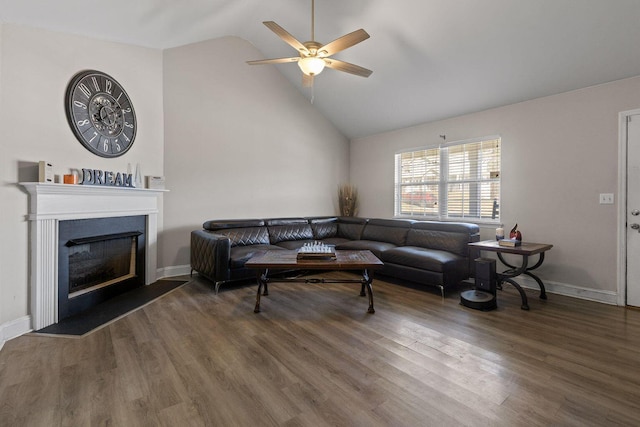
left=0, top=273, right=640, bottom=426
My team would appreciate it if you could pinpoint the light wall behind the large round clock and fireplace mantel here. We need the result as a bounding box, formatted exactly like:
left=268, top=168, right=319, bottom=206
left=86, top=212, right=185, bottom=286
left=0, top=24, right=164, bottom=334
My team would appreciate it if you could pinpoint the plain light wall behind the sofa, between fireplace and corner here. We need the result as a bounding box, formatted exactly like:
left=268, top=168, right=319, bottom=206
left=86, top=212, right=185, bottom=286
left=160, top=37, right=349, bottom=267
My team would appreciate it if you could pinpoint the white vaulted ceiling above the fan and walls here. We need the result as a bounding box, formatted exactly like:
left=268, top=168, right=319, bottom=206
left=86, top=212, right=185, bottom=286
left=0, top=0, right=640, bottom=138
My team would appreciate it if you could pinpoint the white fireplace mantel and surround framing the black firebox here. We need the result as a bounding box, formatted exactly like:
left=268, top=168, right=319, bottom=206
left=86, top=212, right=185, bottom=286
left=20, top=182, right=166, bottom=330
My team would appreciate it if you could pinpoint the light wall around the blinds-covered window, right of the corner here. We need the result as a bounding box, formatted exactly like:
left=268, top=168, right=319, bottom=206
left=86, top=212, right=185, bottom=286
left=351, top=77, right=640, bottom=303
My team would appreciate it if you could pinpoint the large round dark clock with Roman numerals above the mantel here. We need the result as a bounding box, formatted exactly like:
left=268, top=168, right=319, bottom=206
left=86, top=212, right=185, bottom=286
left=65, top=70, right=136, bottom=157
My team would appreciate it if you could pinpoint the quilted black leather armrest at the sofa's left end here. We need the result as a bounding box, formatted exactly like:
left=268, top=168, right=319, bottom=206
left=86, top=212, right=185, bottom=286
left=191, top=230, right=231, bottom=283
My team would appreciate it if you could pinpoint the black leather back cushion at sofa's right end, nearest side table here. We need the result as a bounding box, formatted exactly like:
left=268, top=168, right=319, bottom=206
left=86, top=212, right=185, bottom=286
left=407, top=221, right=480, bottom=257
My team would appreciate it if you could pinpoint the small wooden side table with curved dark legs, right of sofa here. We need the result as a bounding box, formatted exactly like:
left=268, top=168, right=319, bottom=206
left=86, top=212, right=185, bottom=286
left=469, top=240, right=553, bottom=310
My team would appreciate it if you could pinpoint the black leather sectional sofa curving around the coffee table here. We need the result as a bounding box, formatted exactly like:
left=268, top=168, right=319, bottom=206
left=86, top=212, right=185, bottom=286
left=191, top=217, right=480, bottom=296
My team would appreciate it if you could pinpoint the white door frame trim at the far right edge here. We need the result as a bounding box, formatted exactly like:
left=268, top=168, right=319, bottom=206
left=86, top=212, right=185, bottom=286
left=616, top=109, right=640, bottom=306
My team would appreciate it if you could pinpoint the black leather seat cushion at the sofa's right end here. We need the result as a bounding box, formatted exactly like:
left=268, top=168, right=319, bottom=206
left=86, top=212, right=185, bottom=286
left=380, top=246, right=467, bottom=273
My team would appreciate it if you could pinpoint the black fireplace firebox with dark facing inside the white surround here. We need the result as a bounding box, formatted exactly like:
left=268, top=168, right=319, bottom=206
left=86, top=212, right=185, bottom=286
left=58, top=215, right=146, bottom=320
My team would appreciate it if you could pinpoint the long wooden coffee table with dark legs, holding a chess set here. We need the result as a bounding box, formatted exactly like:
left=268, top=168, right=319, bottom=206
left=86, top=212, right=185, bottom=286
left=245, top=250, right=384, bottom=313
